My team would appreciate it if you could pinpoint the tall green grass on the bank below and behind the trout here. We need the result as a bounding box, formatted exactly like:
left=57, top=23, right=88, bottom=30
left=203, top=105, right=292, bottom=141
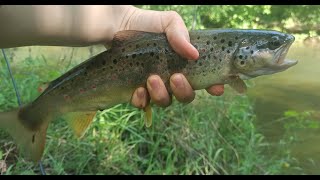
left=0, top=54, right=300, bottom=175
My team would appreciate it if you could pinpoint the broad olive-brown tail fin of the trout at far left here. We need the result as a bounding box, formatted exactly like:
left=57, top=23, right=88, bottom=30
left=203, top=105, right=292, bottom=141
left=0, top=109, right=48, bottom=162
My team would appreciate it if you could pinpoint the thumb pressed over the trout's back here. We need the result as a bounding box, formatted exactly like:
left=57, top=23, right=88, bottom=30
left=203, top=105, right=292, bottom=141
left=161, top=11, right=199, bottom=60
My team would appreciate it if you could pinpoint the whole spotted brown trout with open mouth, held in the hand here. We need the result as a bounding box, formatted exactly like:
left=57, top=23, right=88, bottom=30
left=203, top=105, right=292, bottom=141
left=0, top=29, right=297, bottom=161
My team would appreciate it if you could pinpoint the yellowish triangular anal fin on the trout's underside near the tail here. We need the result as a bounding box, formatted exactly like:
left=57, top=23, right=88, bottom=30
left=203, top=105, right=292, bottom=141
left=64, top=111, right=97, bottom=138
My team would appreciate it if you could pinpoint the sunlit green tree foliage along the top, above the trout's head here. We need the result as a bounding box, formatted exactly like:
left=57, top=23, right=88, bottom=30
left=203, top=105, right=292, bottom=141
left=138, top=5, right=320, bottom=34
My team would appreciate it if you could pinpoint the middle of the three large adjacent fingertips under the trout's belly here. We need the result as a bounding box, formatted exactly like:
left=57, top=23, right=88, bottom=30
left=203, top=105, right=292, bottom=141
left=147, top=75, right=171, bottom=107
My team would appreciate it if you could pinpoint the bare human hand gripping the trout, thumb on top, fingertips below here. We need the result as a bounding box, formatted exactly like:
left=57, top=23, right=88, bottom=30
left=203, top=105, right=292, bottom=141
left=122, top=7, right=224, bottom=108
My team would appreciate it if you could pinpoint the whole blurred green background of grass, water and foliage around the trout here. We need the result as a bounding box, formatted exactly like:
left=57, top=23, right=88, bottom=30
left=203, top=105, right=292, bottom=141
left=0, top=5, right=320, bottom=174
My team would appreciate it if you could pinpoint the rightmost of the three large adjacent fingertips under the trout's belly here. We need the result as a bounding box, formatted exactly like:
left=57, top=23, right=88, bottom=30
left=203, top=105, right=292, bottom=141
left=170, top=73, right=195, bottom=103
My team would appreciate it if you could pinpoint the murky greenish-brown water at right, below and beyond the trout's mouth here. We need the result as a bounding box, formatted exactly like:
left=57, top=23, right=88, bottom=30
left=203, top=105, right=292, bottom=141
left=248, top=44, right=320, bottom=174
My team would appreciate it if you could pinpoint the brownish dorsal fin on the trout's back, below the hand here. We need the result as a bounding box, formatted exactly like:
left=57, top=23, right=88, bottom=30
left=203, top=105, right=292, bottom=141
left=112, top=30, right=160, bottom=47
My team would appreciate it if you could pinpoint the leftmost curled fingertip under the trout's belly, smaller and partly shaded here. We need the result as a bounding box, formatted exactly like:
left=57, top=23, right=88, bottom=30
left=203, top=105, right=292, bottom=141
left=131, top=87, right=150, bottom=109
